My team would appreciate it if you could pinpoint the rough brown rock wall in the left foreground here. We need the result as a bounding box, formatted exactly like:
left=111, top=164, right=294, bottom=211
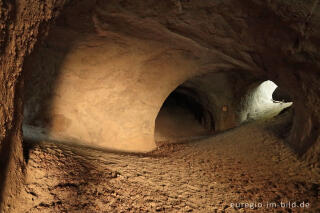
left=0, top=0, right=64, bottom=212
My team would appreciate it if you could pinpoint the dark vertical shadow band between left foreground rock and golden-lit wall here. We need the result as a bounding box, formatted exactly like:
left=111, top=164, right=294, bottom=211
left=23, top=0, right=96, bottom=141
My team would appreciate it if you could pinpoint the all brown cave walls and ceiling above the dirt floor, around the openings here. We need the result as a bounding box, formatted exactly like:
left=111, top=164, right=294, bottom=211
left=0, top=0, right=320, bottom=212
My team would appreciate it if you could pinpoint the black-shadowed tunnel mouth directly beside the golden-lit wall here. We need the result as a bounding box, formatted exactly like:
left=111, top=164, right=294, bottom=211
left=155, top=86, right=215, bottom=145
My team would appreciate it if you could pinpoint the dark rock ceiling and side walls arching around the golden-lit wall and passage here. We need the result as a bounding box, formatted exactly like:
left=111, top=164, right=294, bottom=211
left=0, top=0, right=320, bottom=209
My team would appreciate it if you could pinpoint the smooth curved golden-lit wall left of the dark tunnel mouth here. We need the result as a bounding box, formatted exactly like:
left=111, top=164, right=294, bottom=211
left=25, top=30, right=202, bottom=151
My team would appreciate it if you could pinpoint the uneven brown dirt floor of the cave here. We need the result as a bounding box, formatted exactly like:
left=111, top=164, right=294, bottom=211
left=13, top=113, right=320, bottom=213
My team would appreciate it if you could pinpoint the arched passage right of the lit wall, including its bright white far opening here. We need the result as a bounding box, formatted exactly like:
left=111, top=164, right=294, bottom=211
left=155, top=71, right=292, bottom=145
